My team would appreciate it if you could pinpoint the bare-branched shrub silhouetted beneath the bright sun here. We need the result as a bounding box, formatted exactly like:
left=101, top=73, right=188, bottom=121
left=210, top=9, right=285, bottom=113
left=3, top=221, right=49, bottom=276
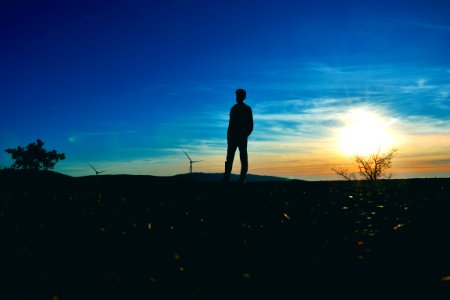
left=332, top=148, right=397, bottom=180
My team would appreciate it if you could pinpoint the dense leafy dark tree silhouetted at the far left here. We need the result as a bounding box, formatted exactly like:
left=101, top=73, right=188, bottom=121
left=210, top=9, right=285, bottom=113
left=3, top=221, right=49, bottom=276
left=5, top=139, right=66, bottom=170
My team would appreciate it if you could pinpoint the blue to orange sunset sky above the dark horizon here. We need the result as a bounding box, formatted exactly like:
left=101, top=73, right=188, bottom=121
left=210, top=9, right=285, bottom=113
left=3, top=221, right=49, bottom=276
left=0, top=0, right=450, bottom=180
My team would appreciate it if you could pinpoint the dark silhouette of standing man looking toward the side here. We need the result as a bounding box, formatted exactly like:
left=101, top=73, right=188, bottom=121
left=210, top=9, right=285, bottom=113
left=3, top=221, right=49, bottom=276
left=224, top=89, right=253, bottom=183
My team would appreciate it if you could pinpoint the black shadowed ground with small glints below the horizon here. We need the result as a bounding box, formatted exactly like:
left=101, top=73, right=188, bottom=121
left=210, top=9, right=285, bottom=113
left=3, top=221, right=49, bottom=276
left=0, top=170, right=450, bottom=300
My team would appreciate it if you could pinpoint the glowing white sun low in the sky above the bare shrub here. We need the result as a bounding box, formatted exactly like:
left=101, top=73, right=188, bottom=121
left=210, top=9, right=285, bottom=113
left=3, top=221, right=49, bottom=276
left=339, top=109, right=393, bottom=155
